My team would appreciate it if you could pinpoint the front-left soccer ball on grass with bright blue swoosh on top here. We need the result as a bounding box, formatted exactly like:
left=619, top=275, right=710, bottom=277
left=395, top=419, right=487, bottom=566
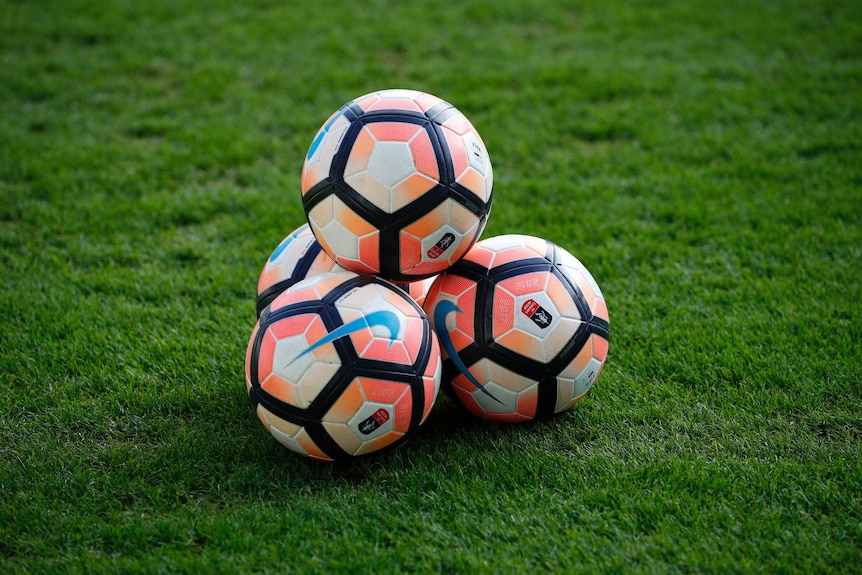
left=246, top=271, right=442, bottom=461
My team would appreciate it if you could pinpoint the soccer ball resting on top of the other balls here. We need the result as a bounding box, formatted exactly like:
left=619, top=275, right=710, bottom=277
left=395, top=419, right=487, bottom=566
left=301, top=90, right=493, bottom=281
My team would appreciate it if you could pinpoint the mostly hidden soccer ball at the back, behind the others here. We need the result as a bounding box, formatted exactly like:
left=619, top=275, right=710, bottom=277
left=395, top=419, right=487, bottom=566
left=255, top=224, right=437, bottom=317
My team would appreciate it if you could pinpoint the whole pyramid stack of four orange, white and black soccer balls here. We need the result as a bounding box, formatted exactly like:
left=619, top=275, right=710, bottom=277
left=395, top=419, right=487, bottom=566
left=246, top=90, right=609, bottom=461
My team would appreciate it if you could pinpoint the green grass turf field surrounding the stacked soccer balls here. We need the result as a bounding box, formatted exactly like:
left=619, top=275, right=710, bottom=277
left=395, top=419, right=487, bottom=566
left=0, top=0, right=862, bottom=574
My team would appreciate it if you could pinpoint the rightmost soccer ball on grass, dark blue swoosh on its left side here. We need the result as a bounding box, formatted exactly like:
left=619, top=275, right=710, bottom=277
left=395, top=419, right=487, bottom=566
left=424, top=235, right=610, bottom=422
